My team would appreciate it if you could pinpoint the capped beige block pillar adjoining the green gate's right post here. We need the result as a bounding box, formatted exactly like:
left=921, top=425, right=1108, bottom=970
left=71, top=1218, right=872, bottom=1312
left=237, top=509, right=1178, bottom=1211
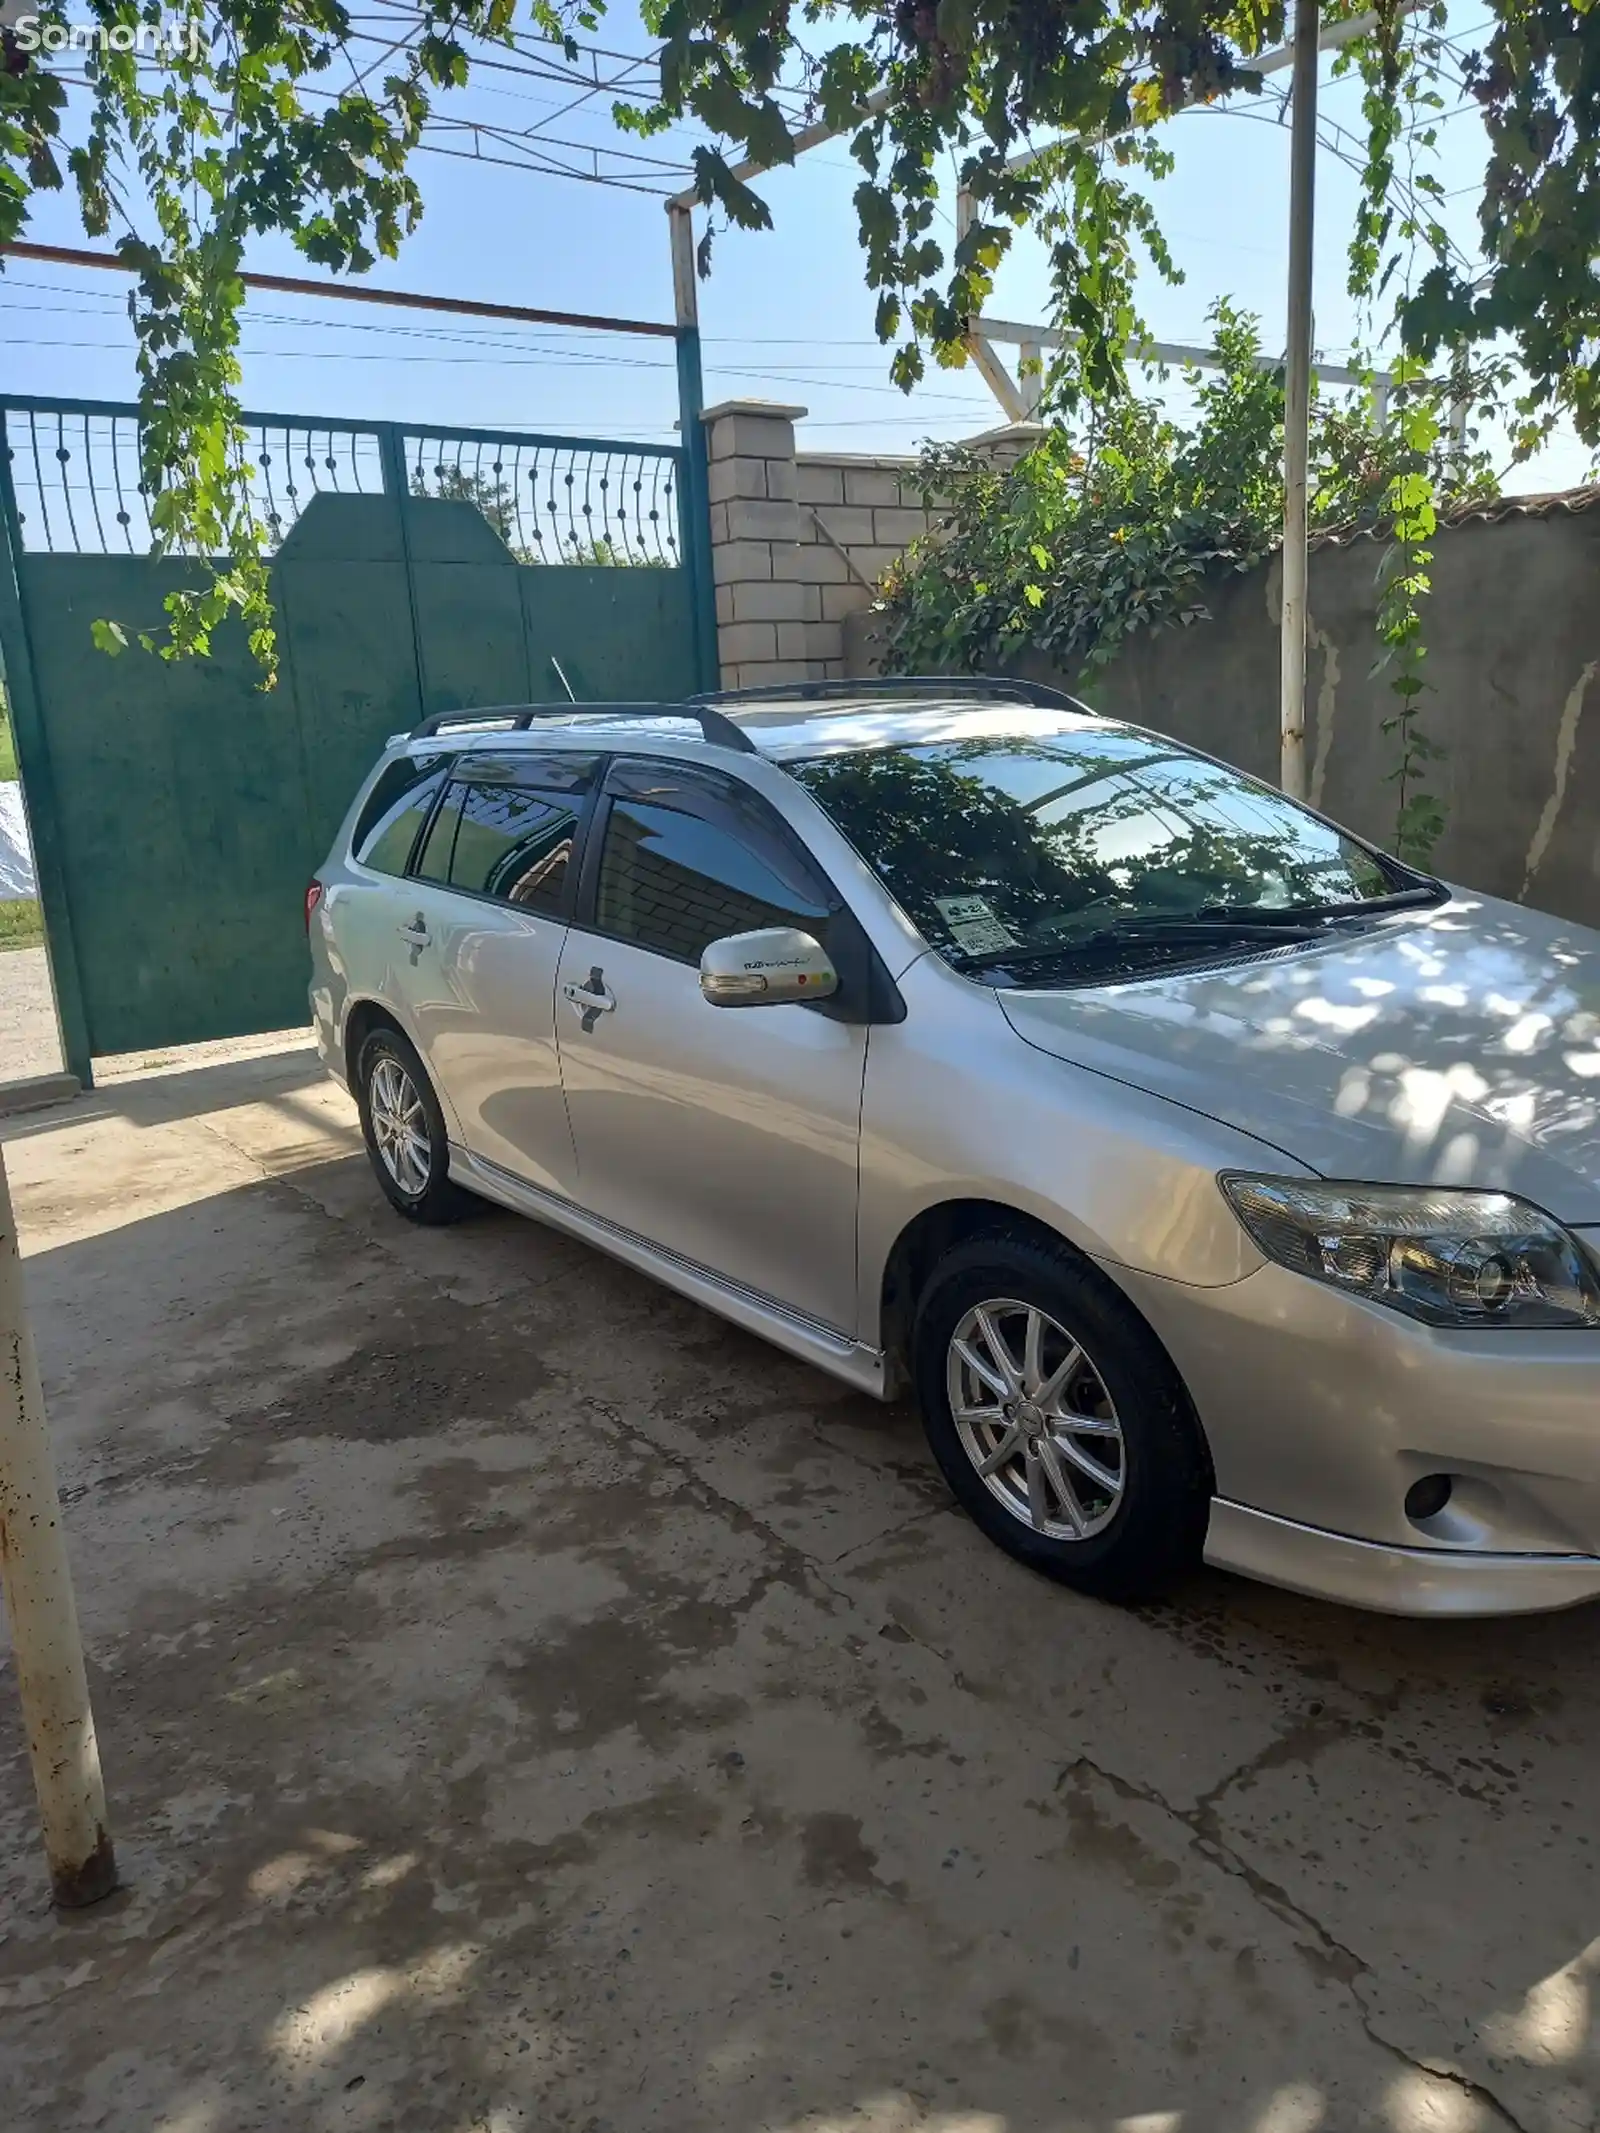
left=702, top=401, right=821, bottom=689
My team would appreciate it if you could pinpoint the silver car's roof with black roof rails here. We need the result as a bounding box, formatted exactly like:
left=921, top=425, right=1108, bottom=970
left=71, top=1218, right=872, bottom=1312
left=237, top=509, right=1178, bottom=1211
left=395, top=680, right=1103, bottom=764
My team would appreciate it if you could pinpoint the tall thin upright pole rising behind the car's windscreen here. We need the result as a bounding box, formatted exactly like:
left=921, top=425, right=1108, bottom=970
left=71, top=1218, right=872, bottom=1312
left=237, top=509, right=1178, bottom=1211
left=1280, top=0, right=1318, bottom=800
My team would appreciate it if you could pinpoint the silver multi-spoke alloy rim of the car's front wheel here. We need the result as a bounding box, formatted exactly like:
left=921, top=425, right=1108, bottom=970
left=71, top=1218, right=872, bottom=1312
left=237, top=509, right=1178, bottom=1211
left=945, top=1297, right=1129, bottom=1540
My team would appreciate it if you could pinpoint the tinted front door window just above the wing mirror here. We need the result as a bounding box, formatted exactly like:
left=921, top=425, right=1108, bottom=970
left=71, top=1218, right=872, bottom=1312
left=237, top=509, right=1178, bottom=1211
left=595, top=783, right=828, bottom=964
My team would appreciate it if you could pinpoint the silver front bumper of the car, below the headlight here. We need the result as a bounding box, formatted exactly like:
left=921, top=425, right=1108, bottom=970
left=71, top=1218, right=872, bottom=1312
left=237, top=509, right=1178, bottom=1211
left=1107, top=1267, right=1600, bottom=1615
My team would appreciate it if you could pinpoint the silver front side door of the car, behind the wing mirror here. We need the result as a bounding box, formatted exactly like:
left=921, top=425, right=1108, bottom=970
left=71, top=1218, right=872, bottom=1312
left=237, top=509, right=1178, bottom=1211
left=557, top=757, right=868, bottom=1335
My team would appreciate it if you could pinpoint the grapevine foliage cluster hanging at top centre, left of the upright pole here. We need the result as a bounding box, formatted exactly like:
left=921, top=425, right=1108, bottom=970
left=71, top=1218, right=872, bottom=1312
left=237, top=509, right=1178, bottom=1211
left=619, top=0, right=1237, bottom=399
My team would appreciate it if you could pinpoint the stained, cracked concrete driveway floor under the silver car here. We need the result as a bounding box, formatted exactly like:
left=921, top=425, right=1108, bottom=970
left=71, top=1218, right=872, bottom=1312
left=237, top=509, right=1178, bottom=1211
left=0, top=1049, right=1600, bottom=2133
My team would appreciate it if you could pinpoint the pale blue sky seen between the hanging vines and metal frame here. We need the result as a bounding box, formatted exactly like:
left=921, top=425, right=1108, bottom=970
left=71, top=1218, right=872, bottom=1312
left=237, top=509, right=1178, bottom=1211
left=0, top=0, right=1587, bottom=488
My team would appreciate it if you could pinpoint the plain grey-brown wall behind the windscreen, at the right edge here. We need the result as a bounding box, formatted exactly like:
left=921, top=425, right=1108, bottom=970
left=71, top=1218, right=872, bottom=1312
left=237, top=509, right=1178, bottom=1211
left=845, top=499, right=1600, bottom=934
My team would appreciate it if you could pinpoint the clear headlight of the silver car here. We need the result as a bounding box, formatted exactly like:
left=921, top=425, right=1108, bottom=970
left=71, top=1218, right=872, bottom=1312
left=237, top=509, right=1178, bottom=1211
left=1218, top=1171, right=1600, bottom=1327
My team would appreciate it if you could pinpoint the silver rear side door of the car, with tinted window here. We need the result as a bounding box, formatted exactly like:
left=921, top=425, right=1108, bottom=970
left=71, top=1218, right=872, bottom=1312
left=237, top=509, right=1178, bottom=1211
left=399, top=749, right=597, bottom=1192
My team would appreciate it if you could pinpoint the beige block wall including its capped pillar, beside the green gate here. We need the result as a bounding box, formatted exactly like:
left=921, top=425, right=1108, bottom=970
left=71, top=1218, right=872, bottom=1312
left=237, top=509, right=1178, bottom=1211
left=704, top=401, right=1039, bottom=689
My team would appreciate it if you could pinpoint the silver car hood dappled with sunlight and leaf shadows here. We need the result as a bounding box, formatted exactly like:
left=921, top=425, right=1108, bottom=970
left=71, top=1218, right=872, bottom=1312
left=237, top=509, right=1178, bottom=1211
left=1001, top=892, right=1600, bottom=1224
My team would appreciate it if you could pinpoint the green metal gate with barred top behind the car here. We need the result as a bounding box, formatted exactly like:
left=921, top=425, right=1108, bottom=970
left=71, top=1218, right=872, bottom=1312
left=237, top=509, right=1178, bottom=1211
left=0, top=399, right=715, bottom=1081
